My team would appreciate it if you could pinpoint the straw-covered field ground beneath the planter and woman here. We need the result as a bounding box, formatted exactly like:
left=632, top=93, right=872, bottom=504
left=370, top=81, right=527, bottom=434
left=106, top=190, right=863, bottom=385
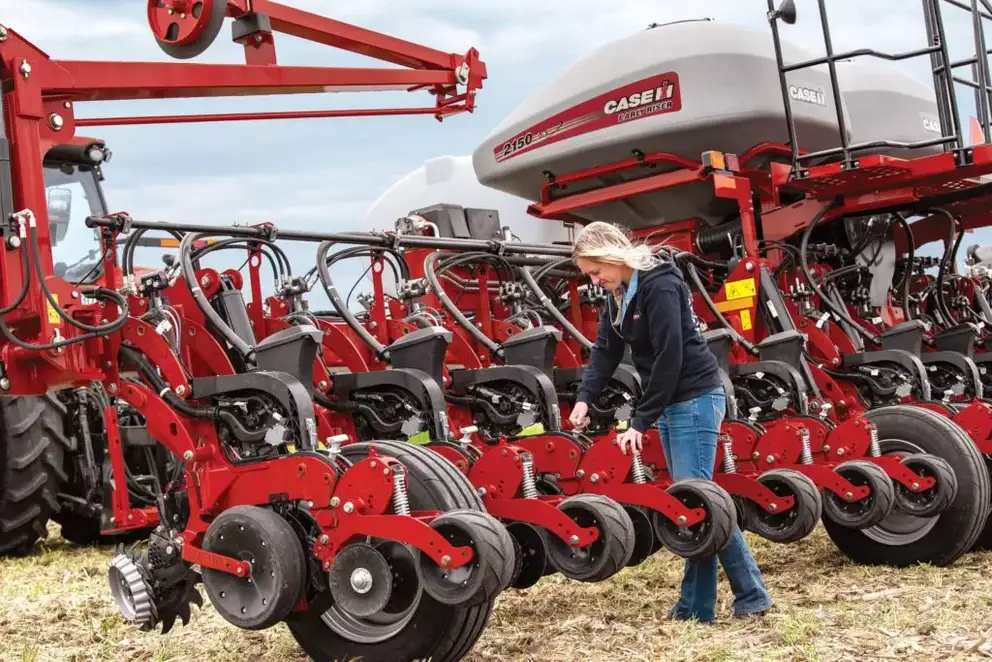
left=0, top=525, right=992, bottom=662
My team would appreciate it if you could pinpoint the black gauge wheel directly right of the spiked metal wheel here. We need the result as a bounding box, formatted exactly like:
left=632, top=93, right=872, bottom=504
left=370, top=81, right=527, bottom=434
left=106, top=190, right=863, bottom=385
left=201, top=506, right=306, bottom=630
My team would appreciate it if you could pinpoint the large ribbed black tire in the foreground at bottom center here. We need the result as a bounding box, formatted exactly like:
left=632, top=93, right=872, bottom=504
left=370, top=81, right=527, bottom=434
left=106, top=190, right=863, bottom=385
left=286, top=441, right=504, bottom=662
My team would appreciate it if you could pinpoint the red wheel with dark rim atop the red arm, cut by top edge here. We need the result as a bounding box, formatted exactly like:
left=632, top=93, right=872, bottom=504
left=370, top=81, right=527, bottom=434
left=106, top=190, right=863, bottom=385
left=148, top=0, right=227, bottom=60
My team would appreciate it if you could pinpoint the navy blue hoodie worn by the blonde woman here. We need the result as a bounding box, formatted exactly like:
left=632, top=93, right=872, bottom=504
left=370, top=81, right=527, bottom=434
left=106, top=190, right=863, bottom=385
left=578, top=262, right=722, bottom=432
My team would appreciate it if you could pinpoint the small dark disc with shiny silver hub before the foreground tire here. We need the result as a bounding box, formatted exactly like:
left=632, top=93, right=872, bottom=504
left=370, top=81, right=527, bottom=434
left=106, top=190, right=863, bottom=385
left=327, top=543, right=393, bottom=618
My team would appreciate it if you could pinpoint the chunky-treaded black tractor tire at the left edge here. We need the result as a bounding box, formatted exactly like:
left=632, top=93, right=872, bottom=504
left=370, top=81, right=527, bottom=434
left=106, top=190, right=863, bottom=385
left=0, top=395, right=73, bottom=556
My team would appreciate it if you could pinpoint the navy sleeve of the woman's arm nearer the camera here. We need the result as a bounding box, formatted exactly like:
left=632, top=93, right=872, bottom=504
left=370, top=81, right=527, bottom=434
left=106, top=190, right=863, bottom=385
left=630, top=287, right=682, bottom=434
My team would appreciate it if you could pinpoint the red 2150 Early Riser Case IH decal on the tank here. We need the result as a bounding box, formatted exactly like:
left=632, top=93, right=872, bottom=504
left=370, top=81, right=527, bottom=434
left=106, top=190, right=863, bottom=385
left=493, top=72, right=682, bottom=163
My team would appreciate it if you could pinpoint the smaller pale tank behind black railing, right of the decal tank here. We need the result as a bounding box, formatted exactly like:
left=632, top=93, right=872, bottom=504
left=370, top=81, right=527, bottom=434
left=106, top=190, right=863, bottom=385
left=836, top=57, right=944, bottom=159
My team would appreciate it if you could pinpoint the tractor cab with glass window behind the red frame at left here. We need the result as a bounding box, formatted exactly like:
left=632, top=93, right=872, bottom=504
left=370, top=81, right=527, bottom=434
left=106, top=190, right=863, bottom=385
left=44, top=137, right=111, bottom=282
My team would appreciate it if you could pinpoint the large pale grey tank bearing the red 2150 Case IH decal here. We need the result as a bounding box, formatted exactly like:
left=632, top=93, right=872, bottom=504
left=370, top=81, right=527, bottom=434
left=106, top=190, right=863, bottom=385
left=473, top=19, right=846, bottom=229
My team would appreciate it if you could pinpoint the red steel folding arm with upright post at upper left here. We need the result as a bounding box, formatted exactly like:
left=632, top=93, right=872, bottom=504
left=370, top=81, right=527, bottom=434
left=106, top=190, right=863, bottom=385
left=0, top=0, right=486, bottom=392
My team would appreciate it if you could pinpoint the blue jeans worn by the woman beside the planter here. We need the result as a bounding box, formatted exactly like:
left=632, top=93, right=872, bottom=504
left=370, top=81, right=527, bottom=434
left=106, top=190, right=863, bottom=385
left=658, top=387, right=772, bottom=622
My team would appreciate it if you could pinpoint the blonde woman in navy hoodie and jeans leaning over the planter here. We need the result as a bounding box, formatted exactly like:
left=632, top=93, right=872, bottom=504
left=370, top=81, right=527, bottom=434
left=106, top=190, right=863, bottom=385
left=569, top=222, right=772, bottom=623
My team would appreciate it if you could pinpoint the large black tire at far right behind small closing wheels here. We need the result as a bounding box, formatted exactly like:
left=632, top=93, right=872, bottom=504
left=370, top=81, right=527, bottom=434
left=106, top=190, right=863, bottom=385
left=823, top=405, right=992, bottom=567
